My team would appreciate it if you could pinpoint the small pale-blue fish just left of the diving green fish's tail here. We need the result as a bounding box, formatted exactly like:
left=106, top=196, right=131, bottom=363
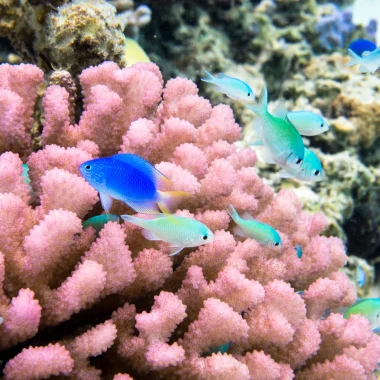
left=201, top=71, right=255, bottom=103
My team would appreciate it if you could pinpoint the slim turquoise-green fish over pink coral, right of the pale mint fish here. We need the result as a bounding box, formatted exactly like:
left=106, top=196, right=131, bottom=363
left=227, top=205, right=282, bottom=247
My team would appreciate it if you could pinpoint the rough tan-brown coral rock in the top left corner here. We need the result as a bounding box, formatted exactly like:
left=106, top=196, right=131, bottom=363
left=0, top=0, right=151, bottom=76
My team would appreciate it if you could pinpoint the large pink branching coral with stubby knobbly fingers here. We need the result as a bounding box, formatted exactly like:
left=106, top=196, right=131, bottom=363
left=0, top=62, right=380, bottom=380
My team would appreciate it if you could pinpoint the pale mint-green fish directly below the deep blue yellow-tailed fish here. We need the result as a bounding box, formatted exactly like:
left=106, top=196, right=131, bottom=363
left=121, top=214, right=214, bottom=256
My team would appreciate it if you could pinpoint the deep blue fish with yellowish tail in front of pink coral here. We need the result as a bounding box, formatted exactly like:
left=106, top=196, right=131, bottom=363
left=79, top=153, right=191, bottom=214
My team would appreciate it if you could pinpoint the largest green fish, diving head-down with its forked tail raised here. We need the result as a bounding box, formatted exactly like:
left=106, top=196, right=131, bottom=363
left=246, top=86, right=305, bottom=170
